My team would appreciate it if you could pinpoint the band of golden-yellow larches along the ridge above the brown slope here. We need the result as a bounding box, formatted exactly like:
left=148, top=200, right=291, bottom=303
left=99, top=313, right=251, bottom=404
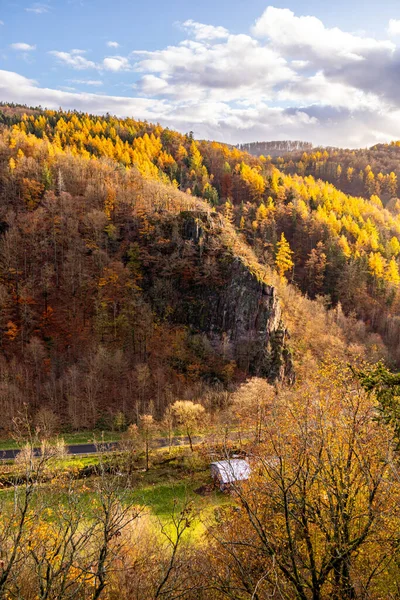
left=2, top=111, right=400, bottom=360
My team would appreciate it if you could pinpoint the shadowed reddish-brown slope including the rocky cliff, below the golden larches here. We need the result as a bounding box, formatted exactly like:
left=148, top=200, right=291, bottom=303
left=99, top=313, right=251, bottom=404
left=0, top=146, right=293, bottom=428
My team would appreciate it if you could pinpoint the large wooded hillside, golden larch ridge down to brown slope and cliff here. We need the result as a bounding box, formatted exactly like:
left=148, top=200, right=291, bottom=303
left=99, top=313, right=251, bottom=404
left=0, top=108, right=390, bottom=429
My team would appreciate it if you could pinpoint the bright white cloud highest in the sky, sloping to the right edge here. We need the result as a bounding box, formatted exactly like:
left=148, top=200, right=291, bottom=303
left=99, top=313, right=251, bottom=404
left=252, top=6, right=400, bottom=108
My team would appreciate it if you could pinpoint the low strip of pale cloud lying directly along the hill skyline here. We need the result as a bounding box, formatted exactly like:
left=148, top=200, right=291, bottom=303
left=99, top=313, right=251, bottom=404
left=0, top=66, right=400, bottom=147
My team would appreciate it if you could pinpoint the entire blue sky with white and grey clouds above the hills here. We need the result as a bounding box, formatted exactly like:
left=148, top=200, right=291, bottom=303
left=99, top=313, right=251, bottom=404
left=0, top=0, right=400, bottom=147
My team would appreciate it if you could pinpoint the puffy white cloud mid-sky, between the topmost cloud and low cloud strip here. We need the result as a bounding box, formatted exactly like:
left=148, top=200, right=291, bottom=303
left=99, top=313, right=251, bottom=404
left=134, top=34, right=296, bottom=100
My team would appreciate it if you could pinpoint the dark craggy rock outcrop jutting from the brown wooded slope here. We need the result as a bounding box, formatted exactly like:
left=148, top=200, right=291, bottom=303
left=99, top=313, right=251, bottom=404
left=141, top=211, right=294, bottom=380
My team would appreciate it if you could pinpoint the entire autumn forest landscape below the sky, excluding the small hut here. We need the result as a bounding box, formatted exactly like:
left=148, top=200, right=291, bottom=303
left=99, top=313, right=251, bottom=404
left=0, top=104, right=400, bottom=600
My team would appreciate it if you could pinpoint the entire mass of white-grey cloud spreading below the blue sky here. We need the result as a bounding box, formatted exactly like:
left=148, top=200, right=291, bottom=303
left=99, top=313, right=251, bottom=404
left=5, top=7, right=400, bottom=147
